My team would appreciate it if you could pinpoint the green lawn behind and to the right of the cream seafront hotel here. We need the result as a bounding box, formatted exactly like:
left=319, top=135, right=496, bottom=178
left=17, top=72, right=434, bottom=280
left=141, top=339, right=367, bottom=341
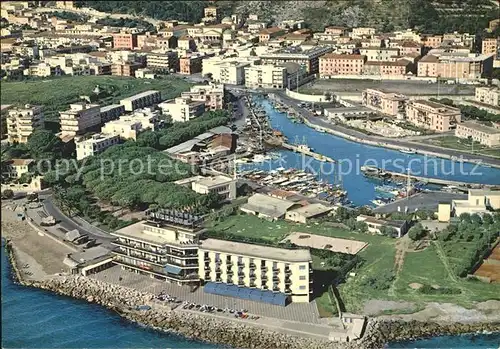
left=211, top=215, right=500, bottom=316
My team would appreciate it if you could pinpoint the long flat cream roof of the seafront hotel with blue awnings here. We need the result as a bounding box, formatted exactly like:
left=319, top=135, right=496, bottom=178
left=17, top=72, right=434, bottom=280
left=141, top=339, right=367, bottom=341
left=200, top=239, right=312, bottom=263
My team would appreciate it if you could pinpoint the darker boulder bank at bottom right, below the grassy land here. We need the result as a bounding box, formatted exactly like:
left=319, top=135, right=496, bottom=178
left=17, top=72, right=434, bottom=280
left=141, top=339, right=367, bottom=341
left=361, top=319, right=500, bottom=348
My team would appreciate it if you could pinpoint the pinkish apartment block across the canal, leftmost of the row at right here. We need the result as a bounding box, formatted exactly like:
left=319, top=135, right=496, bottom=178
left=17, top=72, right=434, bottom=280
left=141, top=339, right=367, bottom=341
left=362, top=89, right=408, bottom=116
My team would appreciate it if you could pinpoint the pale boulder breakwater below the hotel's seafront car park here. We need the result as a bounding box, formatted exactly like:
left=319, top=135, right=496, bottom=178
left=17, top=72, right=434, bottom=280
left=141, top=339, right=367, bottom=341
left=21, top=276, right=348, bottom=349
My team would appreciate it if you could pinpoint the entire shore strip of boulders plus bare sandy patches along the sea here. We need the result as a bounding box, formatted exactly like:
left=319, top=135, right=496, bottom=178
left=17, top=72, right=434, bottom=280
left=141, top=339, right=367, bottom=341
left=2, top=204, right=500, bottom=349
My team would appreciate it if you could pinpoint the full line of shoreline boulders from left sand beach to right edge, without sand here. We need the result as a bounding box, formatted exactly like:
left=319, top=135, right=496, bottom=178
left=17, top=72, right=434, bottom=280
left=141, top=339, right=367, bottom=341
left=5, top=239, right=500, bottom=349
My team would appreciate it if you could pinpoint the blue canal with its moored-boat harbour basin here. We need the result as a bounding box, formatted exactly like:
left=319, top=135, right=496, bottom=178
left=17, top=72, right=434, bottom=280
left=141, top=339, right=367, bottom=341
left=242, top=97, right=500, bottom=205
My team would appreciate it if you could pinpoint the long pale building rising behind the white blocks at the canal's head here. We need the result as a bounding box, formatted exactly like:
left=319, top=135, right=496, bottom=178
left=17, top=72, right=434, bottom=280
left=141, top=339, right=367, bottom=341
left=260, top=46, right=333, bottom=74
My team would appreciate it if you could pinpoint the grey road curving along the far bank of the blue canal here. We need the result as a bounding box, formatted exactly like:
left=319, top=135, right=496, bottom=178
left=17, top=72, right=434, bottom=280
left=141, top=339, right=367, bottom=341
left=274, top=91, right=500, bottom=167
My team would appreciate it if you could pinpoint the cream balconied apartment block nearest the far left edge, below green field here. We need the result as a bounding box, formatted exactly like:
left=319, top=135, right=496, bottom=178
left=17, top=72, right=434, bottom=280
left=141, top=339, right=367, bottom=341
left=6, top=104, right=44, bottom=143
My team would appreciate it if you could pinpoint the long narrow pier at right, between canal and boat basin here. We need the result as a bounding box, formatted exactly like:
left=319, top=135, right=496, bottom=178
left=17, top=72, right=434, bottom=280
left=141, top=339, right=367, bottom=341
left=361, top=166, right=497, bottom=190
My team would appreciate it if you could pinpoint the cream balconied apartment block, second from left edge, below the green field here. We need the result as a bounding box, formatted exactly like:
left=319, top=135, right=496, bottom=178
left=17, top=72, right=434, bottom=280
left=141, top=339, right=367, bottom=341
left=59, top=102, right=101, bottom=137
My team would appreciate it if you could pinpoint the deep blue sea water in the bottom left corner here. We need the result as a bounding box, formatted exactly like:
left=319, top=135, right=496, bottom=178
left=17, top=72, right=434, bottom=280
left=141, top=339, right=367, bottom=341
left=1, top=242, right=217, bottom=349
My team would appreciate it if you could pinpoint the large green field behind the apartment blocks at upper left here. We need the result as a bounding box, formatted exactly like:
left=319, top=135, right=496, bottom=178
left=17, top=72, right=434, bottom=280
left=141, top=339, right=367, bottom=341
left=1, top=75, right=190, bottom=121
